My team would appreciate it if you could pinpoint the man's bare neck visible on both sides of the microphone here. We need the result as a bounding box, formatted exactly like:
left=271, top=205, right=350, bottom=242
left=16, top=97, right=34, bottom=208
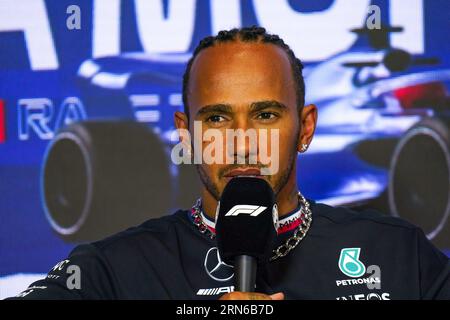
left=202, top=183, right=298, bottom=220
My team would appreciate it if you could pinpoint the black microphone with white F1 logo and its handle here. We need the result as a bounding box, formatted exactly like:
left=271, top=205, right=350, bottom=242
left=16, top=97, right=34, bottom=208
left=216, top=176, right=278, bottom=292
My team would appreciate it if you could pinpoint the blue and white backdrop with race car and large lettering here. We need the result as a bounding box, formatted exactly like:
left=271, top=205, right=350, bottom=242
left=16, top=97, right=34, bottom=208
left=0, top=0, right=450, bottom=298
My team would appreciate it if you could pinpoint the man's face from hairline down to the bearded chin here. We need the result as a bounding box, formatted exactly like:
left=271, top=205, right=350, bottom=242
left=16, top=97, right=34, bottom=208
left=183, top=42, right=300, bottom=200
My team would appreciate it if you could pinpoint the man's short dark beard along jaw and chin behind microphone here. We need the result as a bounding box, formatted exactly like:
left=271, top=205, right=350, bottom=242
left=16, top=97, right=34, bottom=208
left=195, top=129, right=300, bottom=201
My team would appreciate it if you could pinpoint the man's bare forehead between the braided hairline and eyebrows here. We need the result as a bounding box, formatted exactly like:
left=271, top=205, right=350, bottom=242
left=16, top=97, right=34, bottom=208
left=189, top=41, right=295, bottom=107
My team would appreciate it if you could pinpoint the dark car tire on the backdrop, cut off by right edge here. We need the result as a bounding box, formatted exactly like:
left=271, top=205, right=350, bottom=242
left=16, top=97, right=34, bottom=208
left=388, top=117, right=450, bottom=247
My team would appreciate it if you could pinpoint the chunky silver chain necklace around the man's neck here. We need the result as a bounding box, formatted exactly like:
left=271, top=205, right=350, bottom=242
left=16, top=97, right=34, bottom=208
left=191, top=192, right=312, bottom=261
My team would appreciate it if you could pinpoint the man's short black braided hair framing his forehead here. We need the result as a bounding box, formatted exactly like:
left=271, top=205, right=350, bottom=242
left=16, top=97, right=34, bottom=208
left=183, top=26, right=305, bottom=117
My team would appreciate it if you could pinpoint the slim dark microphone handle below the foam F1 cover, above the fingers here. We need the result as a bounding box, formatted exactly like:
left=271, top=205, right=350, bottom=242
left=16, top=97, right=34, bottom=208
left=234, top=255, right=257, bottom=292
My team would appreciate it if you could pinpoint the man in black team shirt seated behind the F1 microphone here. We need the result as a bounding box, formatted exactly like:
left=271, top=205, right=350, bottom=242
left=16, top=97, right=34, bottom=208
left=9, top=27, right=450, bottom=300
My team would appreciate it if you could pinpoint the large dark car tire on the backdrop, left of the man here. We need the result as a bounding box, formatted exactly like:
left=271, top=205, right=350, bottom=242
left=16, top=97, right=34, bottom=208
left=41, top=121, right=172, bottom=242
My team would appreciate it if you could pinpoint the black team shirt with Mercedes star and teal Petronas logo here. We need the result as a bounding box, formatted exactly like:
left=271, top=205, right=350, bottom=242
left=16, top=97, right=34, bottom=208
left=8, top=201, right=450, bottom=300
